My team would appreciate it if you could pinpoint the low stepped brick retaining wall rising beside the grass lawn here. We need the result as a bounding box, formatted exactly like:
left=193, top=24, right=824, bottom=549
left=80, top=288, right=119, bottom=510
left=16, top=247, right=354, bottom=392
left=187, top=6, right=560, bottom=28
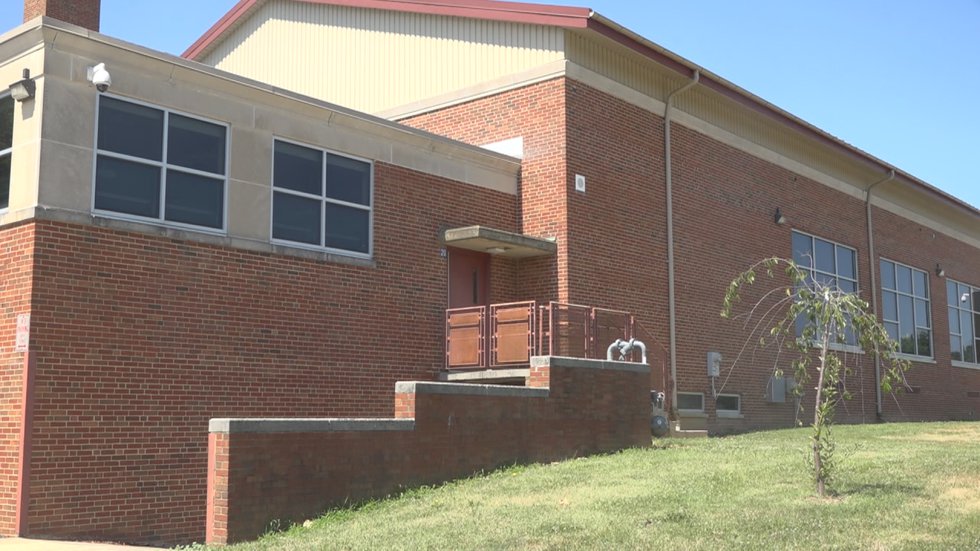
left=208, top=358, right=650, bottom=543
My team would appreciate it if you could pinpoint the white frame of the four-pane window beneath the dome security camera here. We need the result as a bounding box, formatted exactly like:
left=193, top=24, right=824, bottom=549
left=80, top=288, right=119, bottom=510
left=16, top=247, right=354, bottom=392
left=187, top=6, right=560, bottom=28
left=90, top=94, right=231, bottom=235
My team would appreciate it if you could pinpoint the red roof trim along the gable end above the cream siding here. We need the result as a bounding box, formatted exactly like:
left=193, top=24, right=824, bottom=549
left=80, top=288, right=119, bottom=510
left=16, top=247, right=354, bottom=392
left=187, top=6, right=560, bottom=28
left=181, top=0, right=592, bottom=59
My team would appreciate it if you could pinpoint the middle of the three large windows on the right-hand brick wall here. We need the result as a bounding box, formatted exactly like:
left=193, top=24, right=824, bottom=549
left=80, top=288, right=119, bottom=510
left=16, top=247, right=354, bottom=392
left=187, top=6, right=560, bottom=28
left=881, top=259, right=932, bottom=358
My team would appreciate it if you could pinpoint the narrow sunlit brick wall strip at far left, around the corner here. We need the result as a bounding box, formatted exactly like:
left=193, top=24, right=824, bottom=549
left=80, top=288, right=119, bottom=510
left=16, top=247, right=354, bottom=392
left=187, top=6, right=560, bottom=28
left=0, top=224, right=34, bottom=536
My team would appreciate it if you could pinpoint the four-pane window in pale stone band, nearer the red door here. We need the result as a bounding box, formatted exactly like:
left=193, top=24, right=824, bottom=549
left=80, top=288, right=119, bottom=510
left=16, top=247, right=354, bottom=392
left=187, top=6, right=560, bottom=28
left=272, top=140, right=373, bottom=258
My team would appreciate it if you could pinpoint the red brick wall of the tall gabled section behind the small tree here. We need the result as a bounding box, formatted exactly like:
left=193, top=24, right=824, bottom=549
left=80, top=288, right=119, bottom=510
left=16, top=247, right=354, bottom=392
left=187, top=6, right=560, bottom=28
left=405, top=79, right=980, bottom=432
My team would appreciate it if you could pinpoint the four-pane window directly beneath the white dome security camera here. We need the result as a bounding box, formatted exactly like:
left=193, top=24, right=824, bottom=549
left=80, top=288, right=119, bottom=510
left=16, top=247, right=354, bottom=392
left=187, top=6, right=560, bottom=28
left=93, top=96, right=228, bottom=230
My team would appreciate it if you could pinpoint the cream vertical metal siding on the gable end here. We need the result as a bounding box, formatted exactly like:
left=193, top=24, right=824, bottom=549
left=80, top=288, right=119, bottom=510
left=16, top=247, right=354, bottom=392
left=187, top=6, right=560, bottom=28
left=202, top=0, right=564, bottom=113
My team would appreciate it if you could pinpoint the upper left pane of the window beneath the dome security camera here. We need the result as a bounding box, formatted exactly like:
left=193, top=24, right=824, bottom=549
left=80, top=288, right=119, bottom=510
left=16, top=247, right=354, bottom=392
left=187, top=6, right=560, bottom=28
left=99, top=96, right=163, bottom=161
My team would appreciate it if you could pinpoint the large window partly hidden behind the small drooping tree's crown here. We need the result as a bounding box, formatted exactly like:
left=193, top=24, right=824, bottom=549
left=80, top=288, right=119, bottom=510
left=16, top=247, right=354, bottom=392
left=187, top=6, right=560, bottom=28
left=793, top=231, right=857, bottom=346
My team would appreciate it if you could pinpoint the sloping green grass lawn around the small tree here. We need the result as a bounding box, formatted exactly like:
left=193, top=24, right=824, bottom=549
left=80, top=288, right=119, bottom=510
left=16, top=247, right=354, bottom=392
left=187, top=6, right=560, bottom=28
left=209, top=422, right=980, bottom=551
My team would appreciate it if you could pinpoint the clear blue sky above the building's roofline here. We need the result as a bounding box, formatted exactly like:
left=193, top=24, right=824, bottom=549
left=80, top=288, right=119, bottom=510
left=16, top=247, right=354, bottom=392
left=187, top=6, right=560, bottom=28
left=0, top=0, right=980, bottom=207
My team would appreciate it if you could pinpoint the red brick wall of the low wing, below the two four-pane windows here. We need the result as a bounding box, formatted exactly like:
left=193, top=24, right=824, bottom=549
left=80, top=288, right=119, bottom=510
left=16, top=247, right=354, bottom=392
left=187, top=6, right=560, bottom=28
left=21, top=163, right=516, bottom=544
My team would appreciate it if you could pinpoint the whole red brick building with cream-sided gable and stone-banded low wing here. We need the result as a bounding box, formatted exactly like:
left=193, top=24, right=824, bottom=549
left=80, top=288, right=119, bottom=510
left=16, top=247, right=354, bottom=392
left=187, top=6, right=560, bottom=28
left=0, top=0, right=980, bottom=543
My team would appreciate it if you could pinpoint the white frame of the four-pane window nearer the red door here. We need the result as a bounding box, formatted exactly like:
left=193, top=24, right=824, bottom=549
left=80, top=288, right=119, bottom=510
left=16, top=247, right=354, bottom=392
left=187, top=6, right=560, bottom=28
left=269, top=136, right=374, bottom=260
